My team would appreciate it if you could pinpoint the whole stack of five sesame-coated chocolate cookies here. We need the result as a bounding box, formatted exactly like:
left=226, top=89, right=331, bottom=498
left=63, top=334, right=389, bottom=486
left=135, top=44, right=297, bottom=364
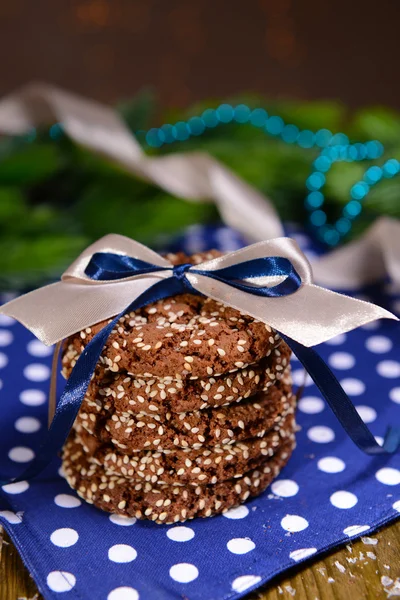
left=63, top=252, right=295, bottom=523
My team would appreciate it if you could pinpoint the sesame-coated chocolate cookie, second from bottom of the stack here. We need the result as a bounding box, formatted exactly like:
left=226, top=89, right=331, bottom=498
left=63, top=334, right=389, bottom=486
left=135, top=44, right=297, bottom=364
left=72, top=413, right=296, bottom=486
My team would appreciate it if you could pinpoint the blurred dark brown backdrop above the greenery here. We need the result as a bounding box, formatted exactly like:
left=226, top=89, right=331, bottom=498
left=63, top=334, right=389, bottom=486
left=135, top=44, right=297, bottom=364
left=0, top=0, right=400, bottom=108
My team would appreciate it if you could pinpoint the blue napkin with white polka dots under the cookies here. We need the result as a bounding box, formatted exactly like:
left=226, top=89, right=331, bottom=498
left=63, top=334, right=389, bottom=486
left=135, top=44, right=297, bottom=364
left=0, top=227, right=400, bottom=600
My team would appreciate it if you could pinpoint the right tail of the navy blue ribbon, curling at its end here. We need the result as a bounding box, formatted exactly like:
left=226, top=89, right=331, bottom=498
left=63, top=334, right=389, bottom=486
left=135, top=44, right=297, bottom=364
left=281, top=334, right=400, bottom=455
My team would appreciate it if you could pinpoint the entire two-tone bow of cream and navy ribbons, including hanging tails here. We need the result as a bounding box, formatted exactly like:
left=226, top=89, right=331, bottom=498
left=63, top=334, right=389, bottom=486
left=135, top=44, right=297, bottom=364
left=0, top=235, right=400, bottom=485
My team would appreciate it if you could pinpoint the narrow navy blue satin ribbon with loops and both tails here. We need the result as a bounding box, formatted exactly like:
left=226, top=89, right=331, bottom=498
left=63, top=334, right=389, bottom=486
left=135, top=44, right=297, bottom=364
left=0, top=253, right=400, bottom=485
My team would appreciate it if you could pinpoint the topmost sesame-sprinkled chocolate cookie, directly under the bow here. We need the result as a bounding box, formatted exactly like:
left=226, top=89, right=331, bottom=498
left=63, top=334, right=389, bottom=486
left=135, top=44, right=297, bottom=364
left=64, top=253, right=281, bottom=379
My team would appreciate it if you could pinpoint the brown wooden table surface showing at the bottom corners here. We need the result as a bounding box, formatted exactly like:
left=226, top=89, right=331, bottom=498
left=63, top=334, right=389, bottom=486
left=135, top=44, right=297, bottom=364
left=0, top=521, right=400, bottom=600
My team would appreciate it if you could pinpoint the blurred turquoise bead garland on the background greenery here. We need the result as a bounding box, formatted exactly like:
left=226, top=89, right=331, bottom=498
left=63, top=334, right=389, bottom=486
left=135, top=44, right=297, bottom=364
left=18, top=104, right=400, bottom=246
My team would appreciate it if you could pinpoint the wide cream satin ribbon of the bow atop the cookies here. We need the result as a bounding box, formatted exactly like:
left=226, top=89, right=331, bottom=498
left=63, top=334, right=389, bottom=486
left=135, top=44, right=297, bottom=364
left=0, top=234, right=396, bottom=346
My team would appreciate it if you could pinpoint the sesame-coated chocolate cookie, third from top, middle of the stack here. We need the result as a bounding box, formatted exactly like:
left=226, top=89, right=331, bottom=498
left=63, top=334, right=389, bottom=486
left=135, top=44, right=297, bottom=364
left=77, top=383, right=292, bottom=452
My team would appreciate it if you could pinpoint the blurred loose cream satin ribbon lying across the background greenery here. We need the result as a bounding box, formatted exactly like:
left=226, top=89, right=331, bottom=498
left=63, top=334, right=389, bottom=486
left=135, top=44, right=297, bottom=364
left=0, top=84, right=400, bottom=289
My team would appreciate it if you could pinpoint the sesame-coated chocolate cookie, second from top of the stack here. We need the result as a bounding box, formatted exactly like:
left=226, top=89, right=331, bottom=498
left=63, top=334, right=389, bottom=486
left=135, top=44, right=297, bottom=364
left=73, top=342, right=290, bottom=416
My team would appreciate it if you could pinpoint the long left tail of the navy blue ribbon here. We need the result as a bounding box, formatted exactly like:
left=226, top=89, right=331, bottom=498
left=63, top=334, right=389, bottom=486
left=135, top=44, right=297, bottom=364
left=0, top=278, right=182, bottom=486
